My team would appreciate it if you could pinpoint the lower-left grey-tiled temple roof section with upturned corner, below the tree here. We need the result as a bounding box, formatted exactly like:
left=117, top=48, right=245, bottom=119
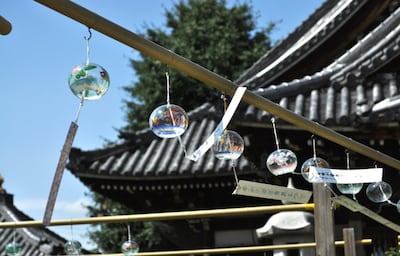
left=68, top=103, right=256, bottom=180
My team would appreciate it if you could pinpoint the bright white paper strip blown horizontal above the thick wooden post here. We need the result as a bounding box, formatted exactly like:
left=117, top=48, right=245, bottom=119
left=308, top=166, right=383, bottom=184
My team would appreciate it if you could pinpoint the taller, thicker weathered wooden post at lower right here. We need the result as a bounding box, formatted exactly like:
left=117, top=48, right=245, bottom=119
left=313, top=183, right=335, bottom=256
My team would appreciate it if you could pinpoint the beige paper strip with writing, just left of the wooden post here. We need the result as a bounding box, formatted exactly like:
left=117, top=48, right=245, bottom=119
left=232, top=180, right=312, bottom=204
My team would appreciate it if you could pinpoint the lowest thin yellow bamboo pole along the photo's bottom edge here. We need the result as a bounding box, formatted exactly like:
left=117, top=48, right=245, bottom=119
left=48, top=239, right=372, bottom=256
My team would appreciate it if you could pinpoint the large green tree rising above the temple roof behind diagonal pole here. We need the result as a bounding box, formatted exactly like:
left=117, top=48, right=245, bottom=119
left=124, top=0, right=274, bottom=131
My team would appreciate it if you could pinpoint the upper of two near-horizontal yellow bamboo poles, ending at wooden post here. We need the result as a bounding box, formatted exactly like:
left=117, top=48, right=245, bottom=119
left=0, top=203, right=314, bottom=228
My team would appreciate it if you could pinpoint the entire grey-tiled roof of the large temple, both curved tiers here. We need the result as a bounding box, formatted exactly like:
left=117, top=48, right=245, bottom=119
left=68, top=0, right=400, bottom=191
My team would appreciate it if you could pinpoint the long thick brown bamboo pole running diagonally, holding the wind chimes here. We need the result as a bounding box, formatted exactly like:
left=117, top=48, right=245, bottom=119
left=35, top=0, right=400, bottom=170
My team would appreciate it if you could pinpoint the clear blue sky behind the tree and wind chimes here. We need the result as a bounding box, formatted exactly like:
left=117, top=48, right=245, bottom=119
left=0, top=0, right=323, bottom=248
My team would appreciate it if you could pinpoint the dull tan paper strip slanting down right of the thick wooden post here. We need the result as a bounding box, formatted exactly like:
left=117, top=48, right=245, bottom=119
left=335, top=196, right=400, bottom=233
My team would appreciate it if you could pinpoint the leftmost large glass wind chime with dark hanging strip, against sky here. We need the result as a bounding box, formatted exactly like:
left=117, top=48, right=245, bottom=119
left=43, top=28, right=110, bottom=226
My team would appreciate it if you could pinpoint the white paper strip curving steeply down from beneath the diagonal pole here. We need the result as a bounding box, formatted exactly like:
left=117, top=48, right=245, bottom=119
left=186, top=87, right=246, bottom=161
